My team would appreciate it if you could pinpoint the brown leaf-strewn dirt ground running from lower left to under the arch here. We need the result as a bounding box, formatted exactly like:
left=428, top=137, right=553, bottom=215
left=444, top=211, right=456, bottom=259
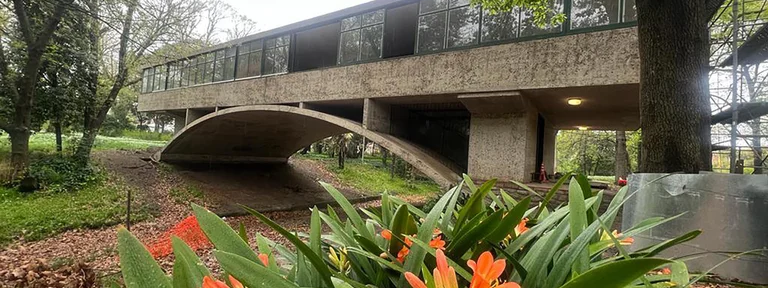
left=0, top=151, right=384, bottom=287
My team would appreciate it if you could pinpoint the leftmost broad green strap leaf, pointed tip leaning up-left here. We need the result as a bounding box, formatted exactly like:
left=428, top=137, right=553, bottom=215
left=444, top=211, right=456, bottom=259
left=117, top=227, right=172, bottom=288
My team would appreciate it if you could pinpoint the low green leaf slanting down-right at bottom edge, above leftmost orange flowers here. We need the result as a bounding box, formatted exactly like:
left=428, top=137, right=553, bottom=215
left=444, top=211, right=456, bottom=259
left=218, top=250, right=302, bottom=288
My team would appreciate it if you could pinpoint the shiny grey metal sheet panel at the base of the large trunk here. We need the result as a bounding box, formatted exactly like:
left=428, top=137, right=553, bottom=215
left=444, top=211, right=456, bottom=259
left=622, top=174, right=768, bottom=284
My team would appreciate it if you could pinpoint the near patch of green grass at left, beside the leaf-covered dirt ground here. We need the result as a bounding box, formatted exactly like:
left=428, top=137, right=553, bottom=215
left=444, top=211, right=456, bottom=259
left=0, top=181, right=150, bottom=245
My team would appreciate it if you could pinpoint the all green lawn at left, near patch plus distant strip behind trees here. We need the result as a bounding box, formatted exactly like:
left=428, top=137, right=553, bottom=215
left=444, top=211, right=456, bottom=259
left=0, top=133, right=159, bottom=247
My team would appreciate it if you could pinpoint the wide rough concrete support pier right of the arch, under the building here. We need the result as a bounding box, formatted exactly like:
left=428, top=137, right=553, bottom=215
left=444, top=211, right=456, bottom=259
left=467, top=110, right=538, bottom=182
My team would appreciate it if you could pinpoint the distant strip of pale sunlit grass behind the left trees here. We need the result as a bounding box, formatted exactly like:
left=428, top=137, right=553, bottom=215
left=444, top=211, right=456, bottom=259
left=0, top=133, right=166, bottom=155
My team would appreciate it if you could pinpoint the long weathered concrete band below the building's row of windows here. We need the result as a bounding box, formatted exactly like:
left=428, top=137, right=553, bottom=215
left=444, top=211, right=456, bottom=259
left=139, top=28, right=640, bottom=111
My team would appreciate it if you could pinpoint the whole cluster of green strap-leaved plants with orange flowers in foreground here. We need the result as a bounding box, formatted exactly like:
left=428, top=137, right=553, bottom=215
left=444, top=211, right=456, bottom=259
left=118, top=175, right=701, bottom=288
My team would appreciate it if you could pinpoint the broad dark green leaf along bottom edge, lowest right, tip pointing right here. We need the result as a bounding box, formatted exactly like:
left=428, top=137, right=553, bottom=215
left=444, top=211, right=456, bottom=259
left=560, top=258, right=672, bottom=288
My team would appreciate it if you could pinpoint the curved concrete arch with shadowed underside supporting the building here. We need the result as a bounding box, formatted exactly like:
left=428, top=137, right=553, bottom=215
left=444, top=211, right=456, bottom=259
left=155, top=105, right=459, bottom=187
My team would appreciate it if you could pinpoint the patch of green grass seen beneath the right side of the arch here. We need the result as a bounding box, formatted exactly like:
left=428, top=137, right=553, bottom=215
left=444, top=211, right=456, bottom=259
left=298, top=154, right=440, bottom=195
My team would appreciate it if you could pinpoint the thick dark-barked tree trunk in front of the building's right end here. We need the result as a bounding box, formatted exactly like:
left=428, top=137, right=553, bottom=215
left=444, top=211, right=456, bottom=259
left=637, top=0, right=712, bottom=173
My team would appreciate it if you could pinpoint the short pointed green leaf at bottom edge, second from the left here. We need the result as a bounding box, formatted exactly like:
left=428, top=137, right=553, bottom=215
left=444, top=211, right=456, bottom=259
left=171, top=236, right=211, bottom=288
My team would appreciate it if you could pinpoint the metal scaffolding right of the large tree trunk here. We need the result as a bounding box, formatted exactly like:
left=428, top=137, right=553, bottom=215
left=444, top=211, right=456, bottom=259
left=709, top=0, right=768, bottom=173
